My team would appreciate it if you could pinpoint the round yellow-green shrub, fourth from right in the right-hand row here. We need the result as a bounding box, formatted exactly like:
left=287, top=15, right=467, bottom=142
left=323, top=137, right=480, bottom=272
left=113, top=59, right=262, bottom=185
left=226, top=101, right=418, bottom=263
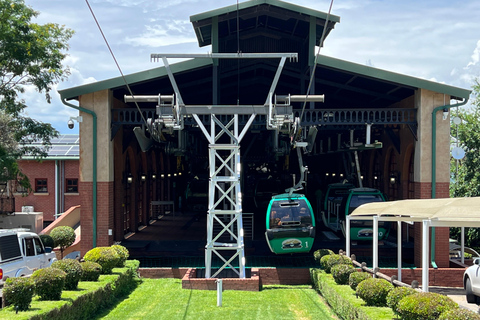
left=356, top=278, right=393, bottom=307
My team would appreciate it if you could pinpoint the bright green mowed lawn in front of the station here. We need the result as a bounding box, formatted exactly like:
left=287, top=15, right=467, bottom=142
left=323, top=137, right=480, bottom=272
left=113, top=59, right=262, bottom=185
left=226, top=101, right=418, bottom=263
left=96, top=279, right=338, bottom=320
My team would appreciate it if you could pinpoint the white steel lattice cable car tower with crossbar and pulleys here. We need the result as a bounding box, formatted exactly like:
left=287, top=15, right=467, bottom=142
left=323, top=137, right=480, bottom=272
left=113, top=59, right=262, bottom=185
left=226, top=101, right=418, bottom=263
left=125, top=53, right=300, bottom=278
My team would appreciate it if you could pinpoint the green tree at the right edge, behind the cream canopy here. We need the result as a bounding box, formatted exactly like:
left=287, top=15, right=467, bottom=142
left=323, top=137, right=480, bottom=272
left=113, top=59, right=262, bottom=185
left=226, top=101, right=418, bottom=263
left=450, top=79, right=480, bottom=249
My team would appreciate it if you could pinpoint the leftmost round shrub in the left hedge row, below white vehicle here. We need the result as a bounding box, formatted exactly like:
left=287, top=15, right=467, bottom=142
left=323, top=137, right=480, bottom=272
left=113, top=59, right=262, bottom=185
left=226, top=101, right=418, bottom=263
left=3, top=278, right=34, bottom=311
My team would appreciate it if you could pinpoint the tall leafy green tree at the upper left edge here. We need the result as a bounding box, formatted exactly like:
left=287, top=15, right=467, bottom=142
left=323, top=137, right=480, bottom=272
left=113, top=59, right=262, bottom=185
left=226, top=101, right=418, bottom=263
left=0, top=0, right=73, bottom=192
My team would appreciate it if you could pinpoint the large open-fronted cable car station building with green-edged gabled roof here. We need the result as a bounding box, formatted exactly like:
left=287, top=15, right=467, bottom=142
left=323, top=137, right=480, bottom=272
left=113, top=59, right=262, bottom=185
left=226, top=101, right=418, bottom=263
left=60, top=0, right=470, bottom=274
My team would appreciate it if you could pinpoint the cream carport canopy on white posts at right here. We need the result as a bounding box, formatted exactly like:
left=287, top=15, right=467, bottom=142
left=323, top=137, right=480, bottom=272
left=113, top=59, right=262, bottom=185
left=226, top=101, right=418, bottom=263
left=345, top=197, right=480, bottom=291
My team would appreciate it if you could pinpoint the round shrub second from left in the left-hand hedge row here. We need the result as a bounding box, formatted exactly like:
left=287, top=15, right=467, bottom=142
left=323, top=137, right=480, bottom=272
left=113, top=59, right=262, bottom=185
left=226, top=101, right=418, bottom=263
left=31, top=267, right=67, bottom=300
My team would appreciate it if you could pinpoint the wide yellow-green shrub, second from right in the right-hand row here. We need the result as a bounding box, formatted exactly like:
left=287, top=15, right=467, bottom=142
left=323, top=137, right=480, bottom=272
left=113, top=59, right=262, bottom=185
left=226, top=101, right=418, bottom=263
left=396, top=292, right=458, bottom=320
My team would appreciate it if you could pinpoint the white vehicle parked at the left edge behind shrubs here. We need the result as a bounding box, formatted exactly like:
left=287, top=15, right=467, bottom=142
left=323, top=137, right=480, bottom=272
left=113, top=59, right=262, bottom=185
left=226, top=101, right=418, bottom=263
left=0, top=229, right=57, bottom=286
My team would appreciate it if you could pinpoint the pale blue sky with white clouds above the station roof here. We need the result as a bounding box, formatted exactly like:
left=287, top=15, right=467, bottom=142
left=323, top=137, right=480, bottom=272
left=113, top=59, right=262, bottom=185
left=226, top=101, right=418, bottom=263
left=24, top=0, right=480, bottom=133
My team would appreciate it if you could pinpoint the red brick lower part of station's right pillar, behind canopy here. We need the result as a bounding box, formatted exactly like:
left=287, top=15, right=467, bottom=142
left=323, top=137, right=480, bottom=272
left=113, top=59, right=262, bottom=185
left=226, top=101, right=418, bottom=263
left=414, top=182, right=450, bottom=268
